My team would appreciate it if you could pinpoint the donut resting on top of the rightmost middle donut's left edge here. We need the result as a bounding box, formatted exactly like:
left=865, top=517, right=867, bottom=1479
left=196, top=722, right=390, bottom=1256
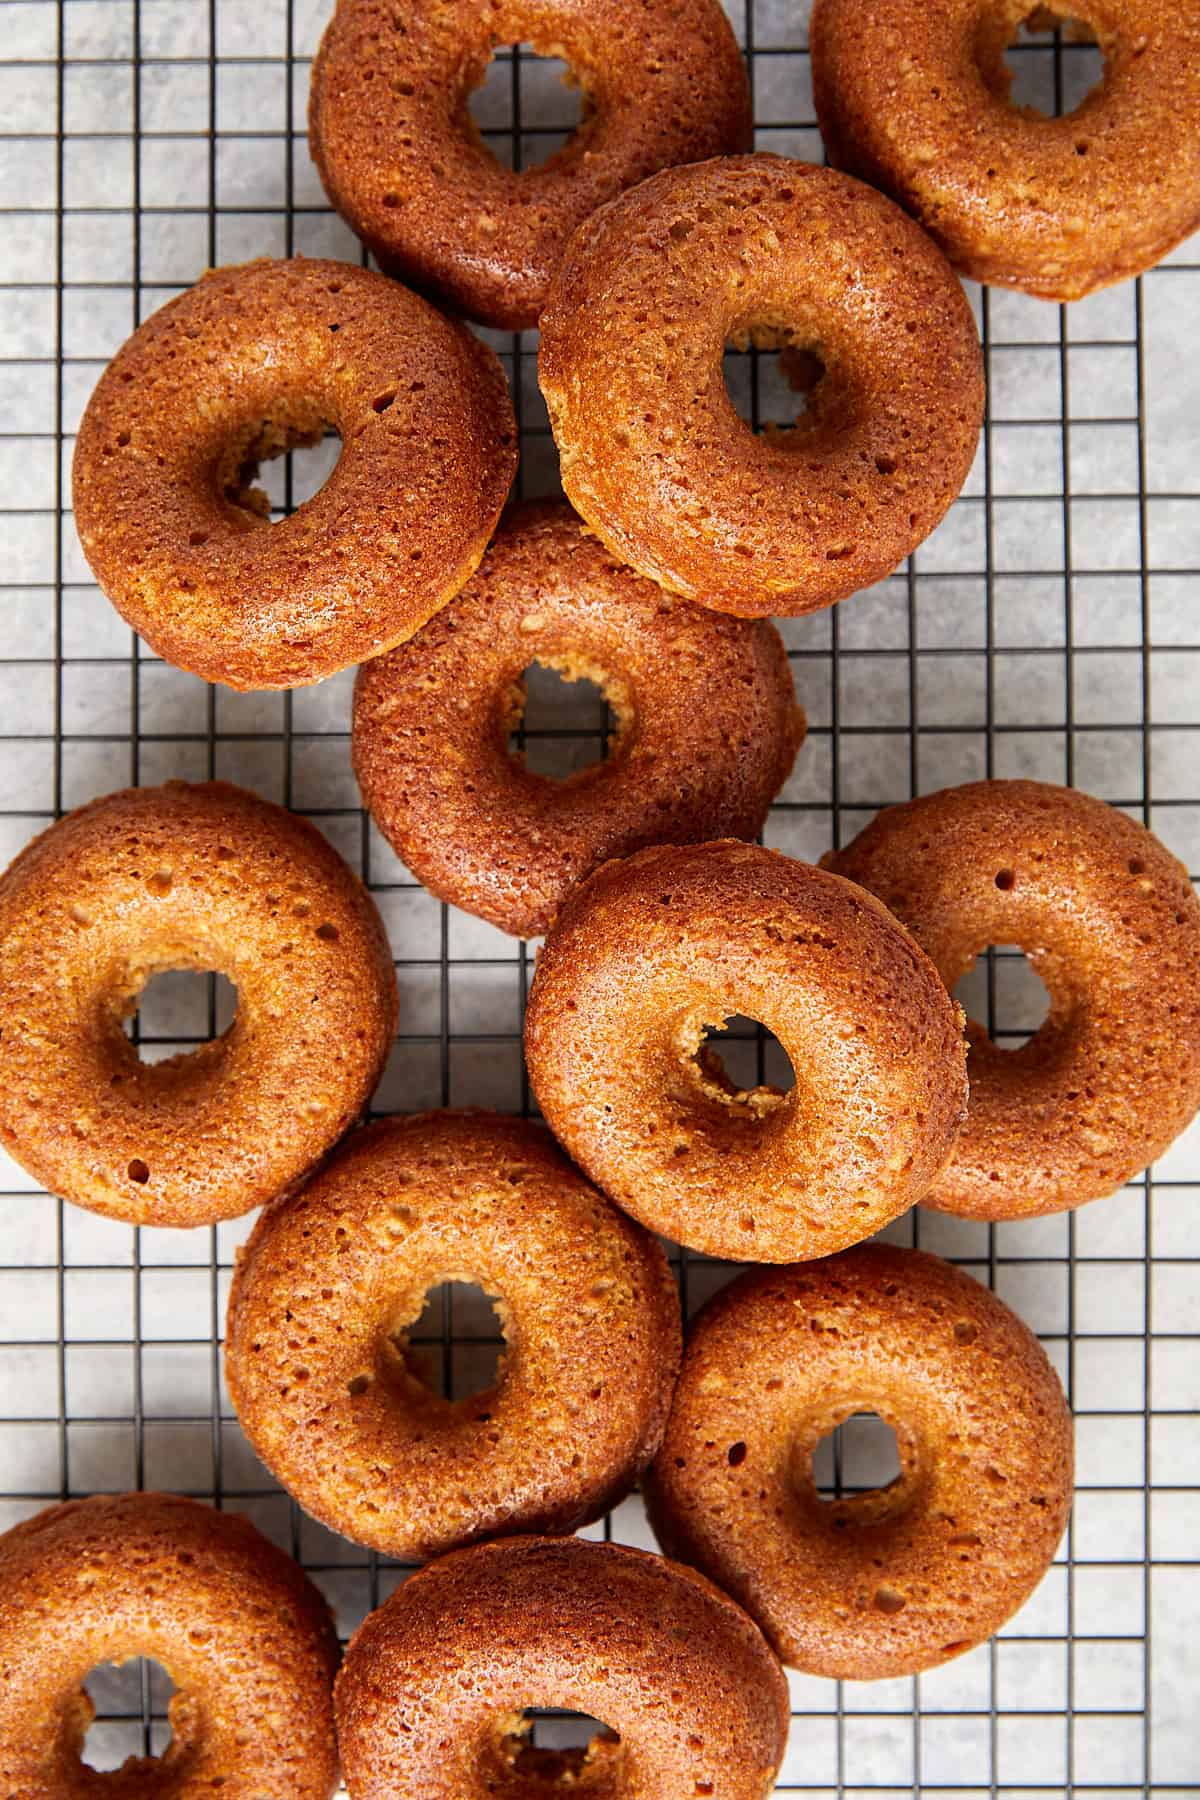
left=525, top=841, right=966, bottom=1262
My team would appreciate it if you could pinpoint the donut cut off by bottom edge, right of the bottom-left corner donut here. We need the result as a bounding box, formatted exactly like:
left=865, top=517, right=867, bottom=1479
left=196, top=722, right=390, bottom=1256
left=335, top=1537, right=788, bottom=1800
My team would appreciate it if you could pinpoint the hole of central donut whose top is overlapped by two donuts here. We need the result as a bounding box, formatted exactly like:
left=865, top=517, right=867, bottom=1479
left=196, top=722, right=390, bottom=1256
left=504, top=657, right=631, bottom=781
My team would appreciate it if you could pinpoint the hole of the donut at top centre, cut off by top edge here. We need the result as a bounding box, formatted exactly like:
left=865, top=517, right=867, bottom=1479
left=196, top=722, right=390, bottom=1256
left=466, top=43, right=590, bottom=175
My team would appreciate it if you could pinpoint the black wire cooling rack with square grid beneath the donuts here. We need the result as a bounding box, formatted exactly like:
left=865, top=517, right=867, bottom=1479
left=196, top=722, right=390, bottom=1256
left=0, top=0, right=1200, bottom=1800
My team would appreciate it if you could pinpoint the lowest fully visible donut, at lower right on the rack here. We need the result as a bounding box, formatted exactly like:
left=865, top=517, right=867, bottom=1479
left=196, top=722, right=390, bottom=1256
left=648, top=1244, right=1072, bottom=1681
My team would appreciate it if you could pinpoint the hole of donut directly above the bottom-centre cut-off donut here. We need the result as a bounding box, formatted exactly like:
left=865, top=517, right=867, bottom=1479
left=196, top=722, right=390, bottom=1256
left=379, top=1280, right=507, bottom=1408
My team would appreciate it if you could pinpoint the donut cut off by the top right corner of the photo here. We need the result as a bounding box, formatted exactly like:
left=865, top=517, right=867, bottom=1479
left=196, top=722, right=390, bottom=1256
left=810, top=0, right=1200, bottom=301
